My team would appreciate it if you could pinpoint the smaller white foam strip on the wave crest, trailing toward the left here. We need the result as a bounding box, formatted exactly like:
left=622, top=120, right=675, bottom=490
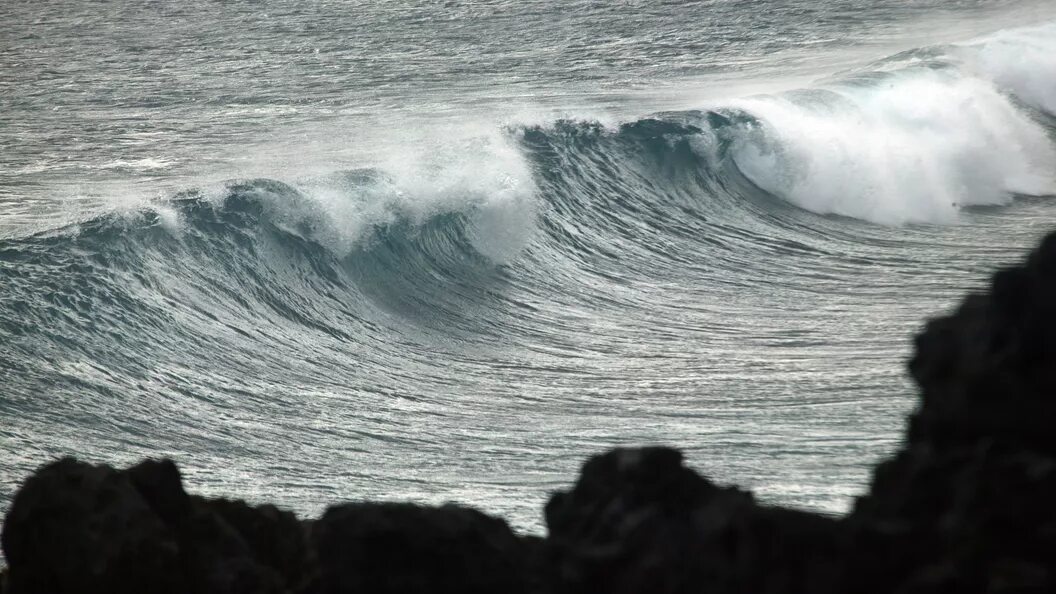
left=99, top=130, right=539, bottom=263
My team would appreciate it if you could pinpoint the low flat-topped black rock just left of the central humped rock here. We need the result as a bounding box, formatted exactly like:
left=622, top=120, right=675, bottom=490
left=310, top=503, right=532, bottom=594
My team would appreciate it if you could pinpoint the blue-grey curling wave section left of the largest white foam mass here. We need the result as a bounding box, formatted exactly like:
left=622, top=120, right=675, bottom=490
left=0, top=114, right=823, bottom=360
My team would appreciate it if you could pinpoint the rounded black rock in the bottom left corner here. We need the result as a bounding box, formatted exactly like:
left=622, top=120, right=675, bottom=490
left=2, top=459, right=186, bottom=594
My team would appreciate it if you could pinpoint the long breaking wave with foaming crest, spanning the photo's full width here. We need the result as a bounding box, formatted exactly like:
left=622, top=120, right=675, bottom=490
left=0, top=25, right=1056, bottom=346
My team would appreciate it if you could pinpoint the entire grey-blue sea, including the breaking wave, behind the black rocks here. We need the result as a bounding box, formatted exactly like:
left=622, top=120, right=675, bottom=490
left=0, top=0, right=1056, bottom=533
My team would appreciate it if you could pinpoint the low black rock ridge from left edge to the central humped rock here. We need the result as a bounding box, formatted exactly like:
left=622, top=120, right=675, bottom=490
left=3, top=459, right=539, bottom=594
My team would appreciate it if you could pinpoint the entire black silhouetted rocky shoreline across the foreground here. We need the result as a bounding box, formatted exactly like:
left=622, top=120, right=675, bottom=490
left=0, top=229, right=1056, bottom=594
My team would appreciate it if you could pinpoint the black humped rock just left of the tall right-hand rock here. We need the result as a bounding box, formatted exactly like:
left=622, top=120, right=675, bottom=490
left=546, top=447, right=840, bottom=594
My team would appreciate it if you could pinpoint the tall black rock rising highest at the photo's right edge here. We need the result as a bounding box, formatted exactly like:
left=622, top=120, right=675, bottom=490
left=847, top=235, right=1056, bottom=594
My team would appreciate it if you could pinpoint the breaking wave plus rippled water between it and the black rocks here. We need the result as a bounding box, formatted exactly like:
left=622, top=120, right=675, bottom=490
left=0, top=18, right=1056, bottom=527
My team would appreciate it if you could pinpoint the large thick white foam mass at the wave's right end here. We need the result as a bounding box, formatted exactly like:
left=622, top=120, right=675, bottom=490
left=724, top=23, right=1056, bottom=224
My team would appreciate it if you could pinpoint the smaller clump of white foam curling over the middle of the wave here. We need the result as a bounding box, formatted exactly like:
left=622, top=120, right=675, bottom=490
left=248, top=130, right=536, bottom=263
